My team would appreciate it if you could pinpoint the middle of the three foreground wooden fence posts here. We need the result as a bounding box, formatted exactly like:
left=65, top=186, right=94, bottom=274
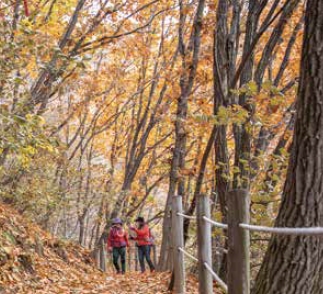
left=196, top=195, right=213, bottom=294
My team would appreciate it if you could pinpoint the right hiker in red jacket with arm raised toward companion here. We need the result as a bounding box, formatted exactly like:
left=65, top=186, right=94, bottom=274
left=130, top=217, right=155, bottom=273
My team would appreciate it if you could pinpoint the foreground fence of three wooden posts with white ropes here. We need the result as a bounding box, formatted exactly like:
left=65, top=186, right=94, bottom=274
left=172, top=190, right=323, bottom=294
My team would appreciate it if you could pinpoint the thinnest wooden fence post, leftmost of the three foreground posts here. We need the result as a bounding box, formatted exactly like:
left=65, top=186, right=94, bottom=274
left=172, top=196, right=185, bottom=294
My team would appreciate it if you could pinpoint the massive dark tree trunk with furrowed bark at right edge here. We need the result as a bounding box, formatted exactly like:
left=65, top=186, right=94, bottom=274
left=253, top=0, right=323, bottom=294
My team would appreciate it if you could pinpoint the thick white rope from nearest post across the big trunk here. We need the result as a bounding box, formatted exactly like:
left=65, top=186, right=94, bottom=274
left=239, top=224, right=323, bottom=236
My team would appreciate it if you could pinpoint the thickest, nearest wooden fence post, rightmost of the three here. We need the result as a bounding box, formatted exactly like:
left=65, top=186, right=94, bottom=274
left=227, top=190, right=250, bottom=294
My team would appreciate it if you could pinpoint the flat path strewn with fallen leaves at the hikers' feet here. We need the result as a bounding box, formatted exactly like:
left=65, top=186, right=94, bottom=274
left=0, top=272, right=198, bottom=294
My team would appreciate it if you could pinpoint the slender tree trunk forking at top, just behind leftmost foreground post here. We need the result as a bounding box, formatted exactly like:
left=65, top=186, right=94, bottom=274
left=159, top=0, right=205, bottom=272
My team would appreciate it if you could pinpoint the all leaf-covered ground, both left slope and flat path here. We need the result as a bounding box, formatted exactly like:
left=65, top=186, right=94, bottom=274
left=0, top=204, right=208, bottom=294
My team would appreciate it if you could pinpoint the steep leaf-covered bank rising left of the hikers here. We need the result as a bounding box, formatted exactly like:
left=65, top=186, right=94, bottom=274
left=0, top=205, right=104, bottom=293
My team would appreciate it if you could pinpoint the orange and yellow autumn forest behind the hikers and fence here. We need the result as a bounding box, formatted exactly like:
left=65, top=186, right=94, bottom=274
left=0, top=0, right=305, bottom=292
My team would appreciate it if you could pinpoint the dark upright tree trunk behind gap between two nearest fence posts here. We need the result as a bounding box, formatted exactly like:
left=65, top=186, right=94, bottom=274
left=213, top=0, right=237, bottom=282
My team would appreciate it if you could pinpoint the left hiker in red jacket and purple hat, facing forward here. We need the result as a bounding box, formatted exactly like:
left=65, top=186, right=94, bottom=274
left=108, top=218, right=129, bottom=274
